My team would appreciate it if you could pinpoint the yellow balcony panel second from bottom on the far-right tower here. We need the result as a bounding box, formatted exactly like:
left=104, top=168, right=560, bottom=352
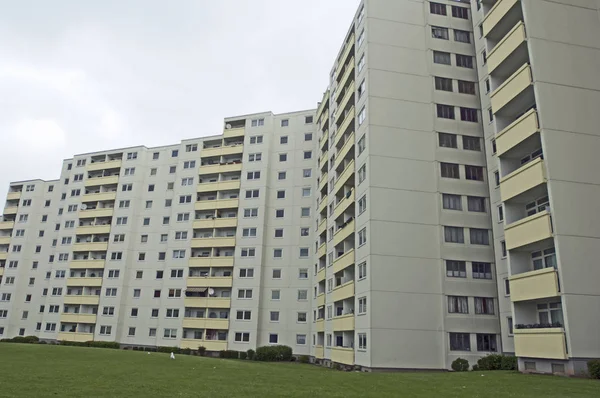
left=510, top=268, right=560, bottom=302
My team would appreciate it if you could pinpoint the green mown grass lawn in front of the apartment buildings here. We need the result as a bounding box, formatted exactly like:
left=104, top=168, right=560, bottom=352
left=0, top=343, right=600, bottom=398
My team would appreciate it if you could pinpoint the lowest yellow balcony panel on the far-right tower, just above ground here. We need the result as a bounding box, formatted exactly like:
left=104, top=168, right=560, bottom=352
left=511, top=328, right=568, bottom=359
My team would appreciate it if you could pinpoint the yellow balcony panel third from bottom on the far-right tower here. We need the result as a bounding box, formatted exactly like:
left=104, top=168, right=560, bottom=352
left=504, top=211, right=552, bottom=250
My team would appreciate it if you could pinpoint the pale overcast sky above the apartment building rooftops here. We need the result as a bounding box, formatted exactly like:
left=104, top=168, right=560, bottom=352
left=0, top=0, right=358, bottom=204
